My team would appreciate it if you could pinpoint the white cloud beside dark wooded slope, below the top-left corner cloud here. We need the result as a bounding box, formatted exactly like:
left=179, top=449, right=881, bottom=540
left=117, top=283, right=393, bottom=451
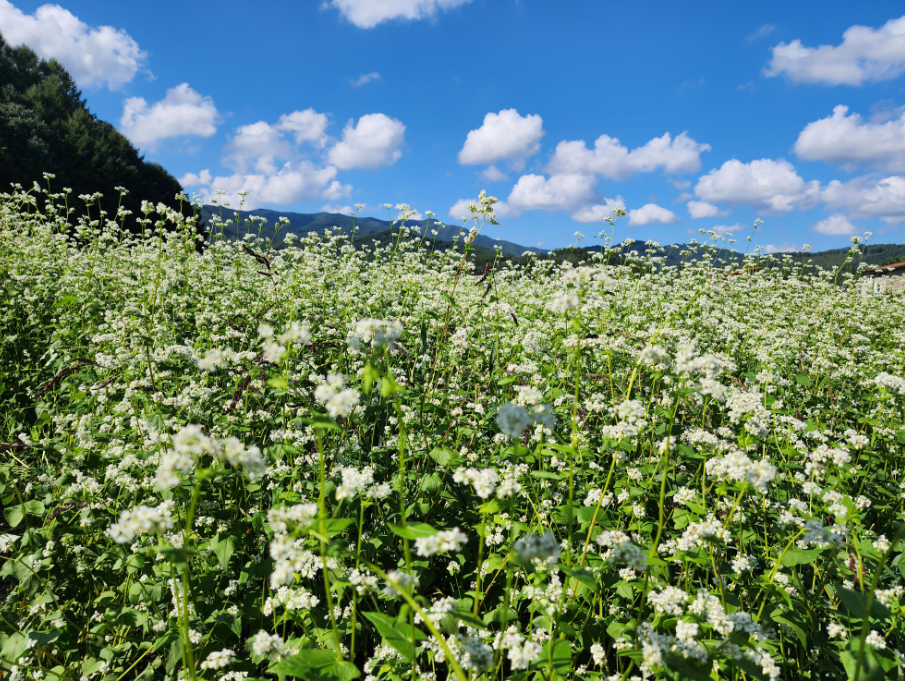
left=119, top=83, right=221, bottom=148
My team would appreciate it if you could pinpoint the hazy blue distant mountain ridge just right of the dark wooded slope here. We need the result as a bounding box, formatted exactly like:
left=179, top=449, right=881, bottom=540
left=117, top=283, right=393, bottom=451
left=201, top=205, right=546, bottom=256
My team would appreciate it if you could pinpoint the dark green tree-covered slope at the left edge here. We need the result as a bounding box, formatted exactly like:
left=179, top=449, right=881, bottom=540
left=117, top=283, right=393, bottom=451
left=0, top=35, right=192, bottom=231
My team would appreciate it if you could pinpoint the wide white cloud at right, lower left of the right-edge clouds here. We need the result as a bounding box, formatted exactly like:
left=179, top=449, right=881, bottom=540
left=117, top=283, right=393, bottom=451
left=694, top=158, right=820, bottom=213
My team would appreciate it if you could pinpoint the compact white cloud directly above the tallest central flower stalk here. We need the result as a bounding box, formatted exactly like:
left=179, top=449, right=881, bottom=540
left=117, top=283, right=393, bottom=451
left=459, top=109, right=544, bottom=167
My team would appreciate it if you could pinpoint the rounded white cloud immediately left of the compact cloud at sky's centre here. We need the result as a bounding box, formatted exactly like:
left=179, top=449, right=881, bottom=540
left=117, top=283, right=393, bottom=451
left=328, top=113, right=405, bottom=169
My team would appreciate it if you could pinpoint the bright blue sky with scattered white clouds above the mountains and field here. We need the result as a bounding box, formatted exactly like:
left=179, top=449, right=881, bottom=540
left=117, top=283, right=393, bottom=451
left=0, top=0, right=905, bottom=250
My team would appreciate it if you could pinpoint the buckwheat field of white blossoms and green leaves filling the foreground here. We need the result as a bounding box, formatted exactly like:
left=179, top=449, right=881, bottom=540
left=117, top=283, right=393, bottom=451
left=0, top=186, right=905, bottom=681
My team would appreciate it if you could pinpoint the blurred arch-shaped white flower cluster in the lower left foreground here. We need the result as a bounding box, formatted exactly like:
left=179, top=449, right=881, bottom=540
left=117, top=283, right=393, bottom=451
left=155, top=425, right=267, bottom=489
